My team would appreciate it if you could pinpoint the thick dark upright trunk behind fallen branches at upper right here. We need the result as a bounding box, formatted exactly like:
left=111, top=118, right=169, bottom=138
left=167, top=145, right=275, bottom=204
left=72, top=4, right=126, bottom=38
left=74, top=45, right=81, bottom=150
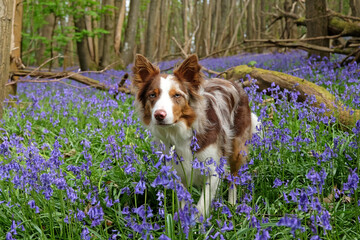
left=305, top=0, right=330, bottom=58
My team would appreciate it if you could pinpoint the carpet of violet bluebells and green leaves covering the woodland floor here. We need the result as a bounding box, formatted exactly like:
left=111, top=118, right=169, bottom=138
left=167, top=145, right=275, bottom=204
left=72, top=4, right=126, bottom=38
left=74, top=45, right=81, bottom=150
left=0, top=49, right=360, bottom=240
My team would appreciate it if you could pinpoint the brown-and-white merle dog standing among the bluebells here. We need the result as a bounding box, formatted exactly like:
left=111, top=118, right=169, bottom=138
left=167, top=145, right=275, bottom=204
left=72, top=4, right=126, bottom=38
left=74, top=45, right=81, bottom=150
left=132, top=55, right=258, bottom=216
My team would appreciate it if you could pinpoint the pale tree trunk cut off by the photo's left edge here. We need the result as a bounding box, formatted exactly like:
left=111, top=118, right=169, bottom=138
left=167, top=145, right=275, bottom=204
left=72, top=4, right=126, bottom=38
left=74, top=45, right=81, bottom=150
left=0, top=0, right=14, bottom=119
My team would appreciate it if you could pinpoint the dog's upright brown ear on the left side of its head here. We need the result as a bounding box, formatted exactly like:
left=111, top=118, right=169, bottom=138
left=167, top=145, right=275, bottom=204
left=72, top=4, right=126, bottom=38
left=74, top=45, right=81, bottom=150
left=132, top=54, right=160, bottom=87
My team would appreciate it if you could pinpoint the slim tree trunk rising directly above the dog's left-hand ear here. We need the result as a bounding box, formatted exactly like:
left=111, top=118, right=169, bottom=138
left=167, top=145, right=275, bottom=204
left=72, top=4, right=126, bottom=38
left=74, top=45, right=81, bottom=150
left=145, top=0, right=160, bottom=61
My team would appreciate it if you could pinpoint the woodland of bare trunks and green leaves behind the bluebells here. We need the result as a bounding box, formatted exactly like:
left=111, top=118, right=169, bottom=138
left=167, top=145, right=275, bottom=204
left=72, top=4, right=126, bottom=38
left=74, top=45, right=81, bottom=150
left=0, top=0, right=360, bottom=116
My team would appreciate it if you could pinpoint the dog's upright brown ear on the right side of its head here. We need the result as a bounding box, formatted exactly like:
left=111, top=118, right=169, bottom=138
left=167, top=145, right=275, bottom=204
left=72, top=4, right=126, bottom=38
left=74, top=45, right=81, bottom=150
left=174, top=54, right=203, bottom=89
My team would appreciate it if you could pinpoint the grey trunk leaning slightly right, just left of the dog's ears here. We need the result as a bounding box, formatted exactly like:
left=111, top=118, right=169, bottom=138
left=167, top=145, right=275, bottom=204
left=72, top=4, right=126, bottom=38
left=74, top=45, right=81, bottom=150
left=121, top=0, right=140, bottom=66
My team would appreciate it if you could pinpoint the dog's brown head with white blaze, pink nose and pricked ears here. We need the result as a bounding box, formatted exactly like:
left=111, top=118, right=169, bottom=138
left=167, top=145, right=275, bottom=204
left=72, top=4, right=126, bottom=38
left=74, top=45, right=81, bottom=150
left=132, top=55, right=203, bottom=127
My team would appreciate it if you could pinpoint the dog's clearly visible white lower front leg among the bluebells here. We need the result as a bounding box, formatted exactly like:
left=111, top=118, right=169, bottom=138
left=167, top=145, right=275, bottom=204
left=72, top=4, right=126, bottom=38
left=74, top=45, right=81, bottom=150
left=196, top=174, right=220, bottom=218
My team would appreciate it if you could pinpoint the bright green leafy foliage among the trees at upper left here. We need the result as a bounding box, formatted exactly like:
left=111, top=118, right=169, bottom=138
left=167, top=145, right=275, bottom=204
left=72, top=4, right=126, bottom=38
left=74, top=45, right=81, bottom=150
left=22, top=0, right=110, bottom=65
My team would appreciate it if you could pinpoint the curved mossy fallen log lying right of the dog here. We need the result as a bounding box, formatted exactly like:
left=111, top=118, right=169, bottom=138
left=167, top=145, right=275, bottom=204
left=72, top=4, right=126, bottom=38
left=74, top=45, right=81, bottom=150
left=222, top=65, right=360, bottom=127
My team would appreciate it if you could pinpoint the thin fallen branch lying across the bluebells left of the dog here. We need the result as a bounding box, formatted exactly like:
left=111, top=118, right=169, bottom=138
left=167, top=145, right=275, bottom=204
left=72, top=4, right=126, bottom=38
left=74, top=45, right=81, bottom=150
left=7, top=70, right=131, bottom=94
